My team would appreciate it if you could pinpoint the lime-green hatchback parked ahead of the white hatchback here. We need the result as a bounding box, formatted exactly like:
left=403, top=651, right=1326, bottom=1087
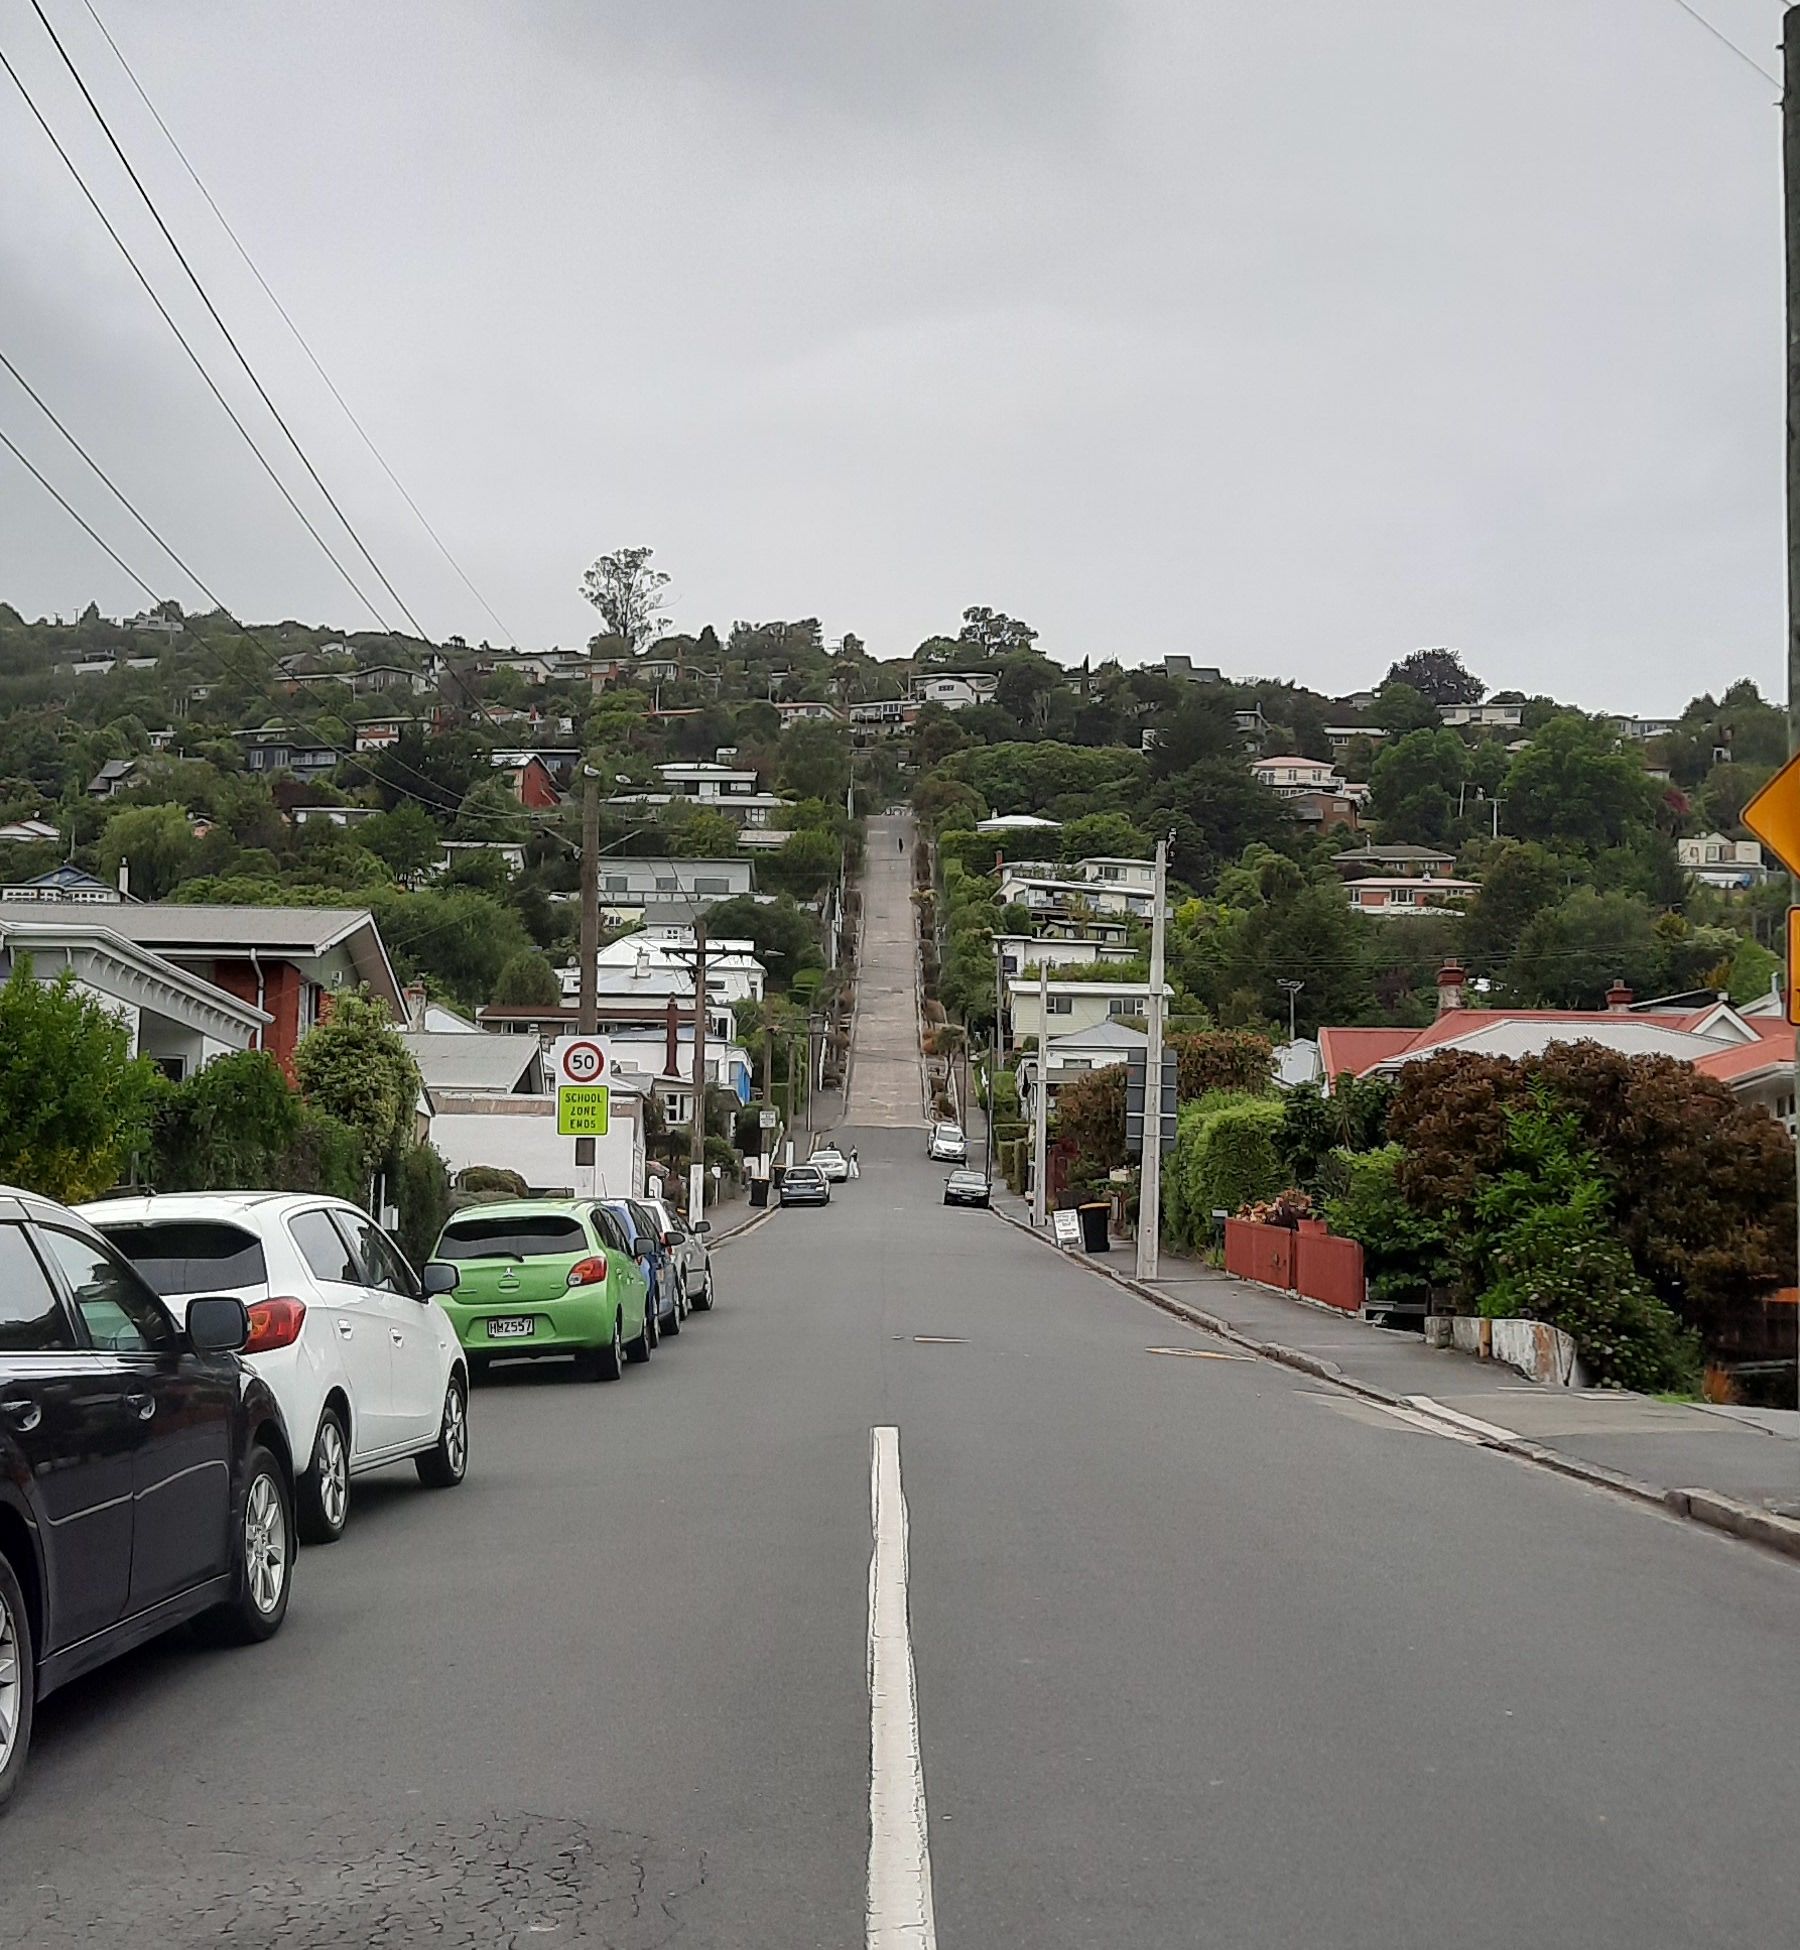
left=433, top=1199, right=655, bottom=1381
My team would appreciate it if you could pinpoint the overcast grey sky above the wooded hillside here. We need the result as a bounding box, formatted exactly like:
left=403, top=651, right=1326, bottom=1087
left=0, top=0, right=1784, bottom=712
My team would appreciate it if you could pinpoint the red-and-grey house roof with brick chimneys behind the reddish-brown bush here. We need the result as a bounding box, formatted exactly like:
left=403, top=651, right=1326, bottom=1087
left=1318, top=961, right=1796, bottom=1133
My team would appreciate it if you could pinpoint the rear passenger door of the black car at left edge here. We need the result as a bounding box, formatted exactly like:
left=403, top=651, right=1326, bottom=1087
left=0, top=1223, right=138, bottom=1654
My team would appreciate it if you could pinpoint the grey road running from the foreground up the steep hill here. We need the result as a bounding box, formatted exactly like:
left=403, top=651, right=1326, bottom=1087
left=0, top=829, right=1800, bottom=1950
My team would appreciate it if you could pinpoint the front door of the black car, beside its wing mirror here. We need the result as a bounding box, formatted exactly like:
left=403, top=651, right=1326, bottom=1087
left=39, top=1227, right=238, bottom=1613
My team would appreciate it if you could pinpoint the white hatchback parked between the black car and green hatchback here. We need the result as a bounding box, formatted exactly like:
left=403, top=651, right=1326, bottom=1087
left=78, top=1191, right=468, bottom=1544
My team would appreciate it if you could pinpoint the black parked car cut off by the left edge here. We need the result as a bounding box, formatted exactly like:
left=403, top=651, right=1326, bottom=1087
left=0, top=1188, right=294, bottom=1812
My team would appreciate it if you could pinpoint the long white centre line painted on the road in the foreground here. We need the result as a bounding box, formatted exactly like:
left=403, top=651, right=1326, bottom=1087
left=866, top=1429, right=938, bottom=1950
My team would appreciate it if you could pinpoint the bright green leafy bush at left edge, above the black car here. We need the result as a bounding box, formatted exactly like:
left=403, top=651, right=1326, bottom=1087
left=0, top=956, right=158, bottom=1201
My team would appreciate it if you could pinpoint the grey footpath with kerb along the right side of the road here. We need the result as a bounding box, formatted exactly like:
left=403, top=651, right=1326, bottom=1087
left=995, top=1188, right=1800, bottom=1558
